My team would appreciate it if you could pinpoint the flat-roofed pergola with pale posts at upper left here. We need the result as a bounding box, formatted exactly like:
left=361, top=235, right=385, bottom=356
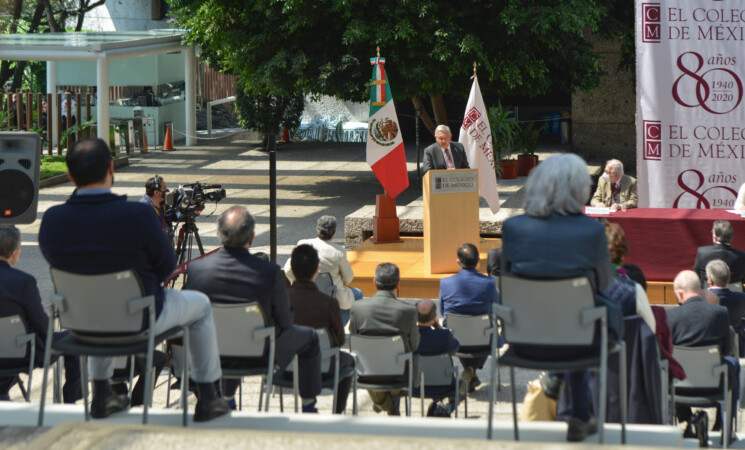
left=0, top=30, right=197, bottom=145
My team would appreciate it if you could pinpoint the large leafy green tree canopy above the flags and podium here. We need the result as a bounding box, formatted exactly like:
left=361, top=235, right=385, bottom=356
left=170, top=0, right=622, bottom=131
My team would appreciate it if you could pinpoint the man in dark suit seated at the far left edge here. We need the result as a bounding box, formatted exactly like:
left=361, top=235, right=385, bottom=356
left=0, top=225, right=83, bottom=403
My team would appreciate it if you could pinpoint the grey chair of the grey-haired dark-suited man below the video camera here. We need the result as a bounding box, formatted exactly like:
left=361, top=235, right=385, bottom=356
left=211, top=302, right=276, bottom=411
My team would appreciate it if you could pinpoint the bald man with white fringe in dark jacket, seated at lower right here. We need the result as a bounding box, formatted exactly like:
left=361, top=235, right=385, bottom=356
left=667, top=270, right=740, bottom=442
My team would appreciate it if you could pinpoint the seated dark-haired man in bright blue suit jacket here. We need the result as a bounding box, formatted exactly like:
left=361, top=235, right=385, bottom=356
left=440, top=244, right=499, bottom=393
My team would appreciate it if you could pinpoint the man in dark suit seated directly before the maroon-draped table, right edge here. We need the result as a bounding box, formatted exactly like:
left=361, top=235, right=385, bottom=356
left=693, top=220, right=745, bottom=287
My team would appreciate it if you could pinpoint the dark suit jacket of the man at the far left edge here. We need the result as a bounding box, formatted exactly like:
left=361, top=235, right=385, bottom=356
left=0, top=261, right=49, bottom=365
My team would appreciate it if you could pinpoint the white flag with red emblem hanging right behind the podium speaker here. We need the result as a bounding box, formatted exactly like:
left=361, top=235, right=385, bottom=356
left=458, top=76, right=499, bottom=214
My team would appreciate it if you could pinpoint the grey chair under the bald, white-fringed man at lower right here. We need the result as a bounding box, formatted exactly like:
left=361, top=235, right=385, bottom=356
left=673, top=345, right=733, bottom=448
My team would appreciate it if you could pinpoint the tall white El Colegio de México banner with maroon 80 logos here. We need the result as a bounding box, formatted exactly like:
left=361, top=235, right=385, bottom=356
left=636, top=0, right=745, bottom=209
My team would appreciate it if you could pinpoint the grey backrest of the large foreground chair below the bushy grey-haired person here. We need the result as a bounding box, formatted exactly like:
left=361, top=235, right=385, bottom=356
left=496, top=274, right=595, bottom=345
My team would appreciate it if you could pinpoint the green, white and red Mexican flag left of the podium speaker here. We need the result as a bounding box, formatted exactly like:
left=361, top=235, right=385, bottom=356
left=367, top=56, right=409, bottom=198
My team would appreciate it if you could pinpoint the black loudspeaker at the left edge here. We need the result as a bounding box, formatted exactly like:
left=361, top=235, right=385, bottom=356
left=0, top=131, right=41, bottom=224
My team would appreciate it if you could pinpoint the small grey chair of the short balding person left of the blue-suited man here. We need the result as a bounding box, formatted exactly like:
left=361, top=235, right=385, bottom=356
left=414, top=353, right=468, bottom=419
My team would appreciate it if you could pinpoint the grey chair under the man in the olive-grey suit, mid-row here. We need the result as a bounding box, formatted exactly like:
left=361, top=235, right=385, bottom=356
left=349, top=334, right=414, bottom=416
